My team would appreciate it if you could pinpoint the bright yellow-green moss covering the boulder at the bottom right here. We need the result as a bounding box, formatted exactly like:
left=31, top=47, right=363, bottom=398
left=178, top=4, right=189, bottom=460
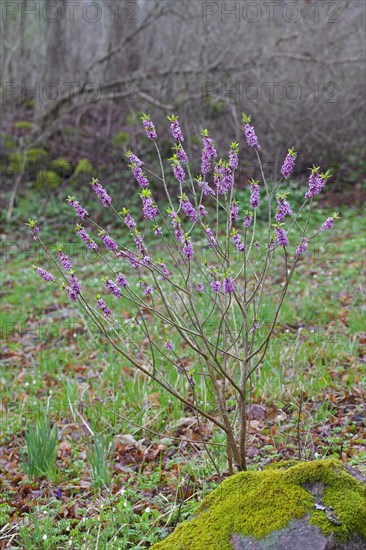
left=153, top=460, right=366, bottom=550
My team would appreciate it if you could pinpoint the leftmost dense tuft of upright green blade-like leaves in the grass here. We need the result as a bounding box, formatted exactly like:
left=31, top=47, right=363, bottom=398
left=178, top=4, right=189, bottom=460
left=22, top=418, right=57, bottom=479
